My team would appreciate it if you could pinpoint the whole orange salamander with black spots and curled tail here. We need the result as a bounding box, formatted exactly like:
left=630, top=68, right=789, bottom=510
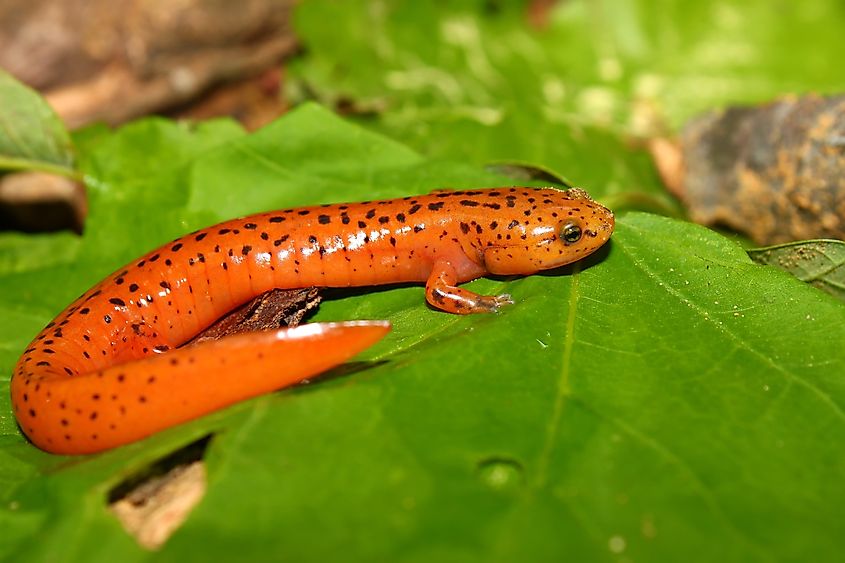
left=11, top=188, right=614, bottom=454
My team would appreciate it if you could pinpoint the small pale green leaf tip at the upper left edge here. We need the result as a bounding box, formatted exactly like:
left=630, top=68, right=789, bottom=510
left=0, top=69, right=76, bottom=177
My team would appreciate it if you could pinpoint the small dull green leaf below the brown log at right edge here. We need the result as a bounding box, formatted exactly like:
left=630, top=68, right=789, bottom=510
left=748, top=240, right=845, bottom=301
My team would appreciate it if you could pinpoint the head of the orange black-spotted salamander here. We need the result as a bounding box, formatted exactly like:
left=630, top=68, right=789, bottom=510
left=478, top=188, right=614, bottom=274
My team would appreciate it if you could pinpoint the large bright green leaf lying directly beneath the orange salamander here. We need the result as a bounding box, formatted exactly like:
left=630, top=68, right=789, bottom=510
left=0, top=105, right=845, bottom=562
